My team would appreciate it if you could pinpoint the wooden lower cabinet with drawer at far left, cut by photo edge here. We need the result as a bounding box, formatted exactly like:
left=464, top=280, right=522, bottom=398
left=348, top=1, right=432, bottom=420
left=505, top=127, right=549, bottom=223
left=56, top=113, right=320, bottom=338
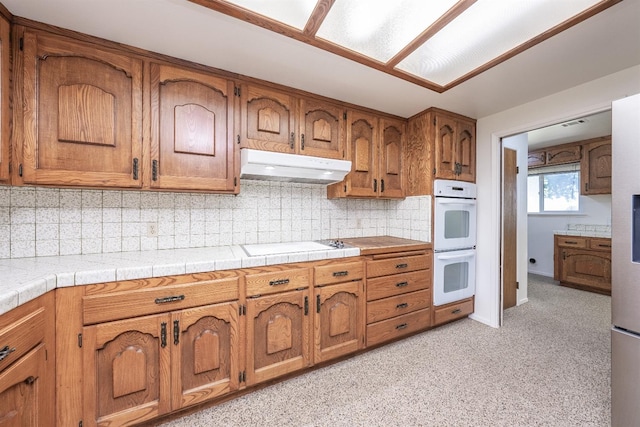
left=0, top=293, right=55, bottom=427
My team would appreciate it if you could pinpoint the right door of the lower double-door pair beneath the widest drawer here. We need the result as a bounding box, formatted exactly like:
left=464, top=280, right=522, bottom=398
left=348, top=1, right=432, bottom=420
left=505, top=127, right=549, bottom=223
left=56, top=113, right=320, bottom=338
left=171, top=302, right=240, bottom=410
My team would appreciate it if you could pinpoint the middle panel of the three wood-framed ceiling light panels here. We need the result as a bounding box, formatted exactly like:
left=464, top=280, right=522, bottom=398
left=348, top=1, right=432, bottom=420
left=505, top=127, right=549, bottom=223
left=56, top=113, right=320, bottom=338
left=316, top=0, right=457, bottom=62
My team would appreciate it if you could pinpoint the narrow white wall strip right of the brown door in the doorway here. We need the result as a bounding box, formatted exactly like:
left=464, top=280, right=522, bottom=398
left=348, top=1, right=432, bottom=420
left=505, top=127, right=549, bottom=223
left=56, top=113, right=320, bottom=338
left=502, top=134, right=529, bottom=305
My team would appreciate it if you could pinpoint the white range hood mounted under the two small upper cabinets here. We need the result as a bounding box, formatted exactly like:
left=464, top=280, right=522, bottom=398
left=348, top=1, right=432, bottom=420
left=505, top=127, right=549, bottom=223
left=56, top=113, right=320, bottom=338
left=240, top=148, right=351, bottom=184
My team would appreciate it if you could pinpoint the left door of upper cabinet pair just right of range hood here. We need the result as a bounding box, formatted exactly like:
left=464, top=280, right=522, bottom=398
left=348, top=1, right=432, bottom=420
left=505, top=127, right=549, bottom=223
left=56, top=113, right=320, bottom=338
left=346, top=111, right=379, bottom=197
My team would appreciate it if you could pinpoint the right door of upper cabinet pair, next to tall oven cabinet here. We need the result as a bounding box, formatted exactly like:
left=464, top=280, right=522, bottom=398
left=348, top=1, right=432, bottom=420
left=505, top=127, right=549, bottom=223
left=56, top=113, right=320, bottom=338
left=380, top=119, right=406, bottom=198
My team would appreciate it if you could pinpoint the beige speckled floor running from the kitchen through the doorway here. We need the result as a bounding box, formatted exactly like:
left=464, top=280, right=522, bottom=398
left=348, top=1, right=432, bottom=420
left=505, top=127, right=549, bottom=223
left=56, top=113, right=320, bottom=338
left=154, top=275, right=611, bottom=427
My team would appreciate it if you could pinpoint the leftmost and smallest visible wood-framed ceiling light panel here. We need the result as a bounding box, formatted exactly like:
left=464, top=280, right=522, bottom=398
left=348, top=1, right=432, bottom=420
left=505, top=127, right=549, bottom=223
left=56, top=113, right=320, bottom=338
left=225, top=0, right=317, bottom=30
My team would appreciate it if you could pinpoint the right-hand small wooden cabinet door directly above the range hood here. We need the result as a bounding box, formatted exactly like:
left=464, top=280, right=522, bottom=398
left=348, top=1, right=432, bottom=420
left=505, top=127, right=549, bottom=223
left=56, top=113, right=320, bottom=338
left=298, top=98, right=345, bottom=159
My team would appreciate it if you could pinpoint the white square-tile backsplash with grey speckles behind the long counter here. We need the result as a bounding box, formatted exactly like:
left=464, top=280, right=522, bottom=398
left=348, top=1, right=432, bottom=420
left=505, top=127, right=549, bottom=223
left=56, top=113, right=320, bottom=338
left=0, top=181, right=431, bottom=260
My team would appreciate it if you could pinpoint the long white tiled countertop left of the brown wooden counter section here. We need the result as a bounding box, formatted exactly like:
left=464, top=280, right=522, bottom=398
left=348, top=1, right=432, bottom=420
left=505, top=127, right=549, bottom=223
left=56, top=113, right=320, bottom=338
left=0, top=245, right=360, bottom=314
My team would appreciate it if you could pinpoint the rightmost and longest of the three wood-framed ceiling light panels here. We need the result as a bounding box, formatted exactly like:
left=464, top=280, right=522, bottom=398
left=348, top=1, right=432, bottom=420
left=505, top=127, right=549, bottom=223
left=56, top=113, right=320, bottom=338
left=396, top=0, right=600, bottom=86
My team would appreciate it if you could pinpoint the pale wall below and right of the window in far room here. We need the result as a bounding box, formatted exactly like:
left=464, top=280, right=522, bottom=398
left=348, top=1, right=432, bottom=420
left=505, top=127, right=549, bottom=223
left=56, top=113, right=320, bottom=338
left=527, top=194, right=611, bottom=277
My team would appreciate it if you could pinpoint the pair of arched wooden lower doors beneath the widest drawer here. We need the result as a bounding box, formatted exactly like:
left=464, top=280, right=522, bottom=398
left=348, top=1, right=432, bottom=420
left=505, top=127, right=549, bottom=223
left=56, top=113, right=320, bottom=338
left=83, top=302, right=239, bottom=426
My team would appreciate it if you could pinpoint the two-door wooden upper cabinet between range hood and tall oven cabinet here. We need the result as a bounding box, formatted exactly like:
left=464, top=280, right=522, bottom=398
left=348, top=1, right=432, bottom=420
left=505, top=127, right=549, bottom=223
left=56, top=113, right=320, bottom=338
left=327, top=110, right=406, bottom=199
